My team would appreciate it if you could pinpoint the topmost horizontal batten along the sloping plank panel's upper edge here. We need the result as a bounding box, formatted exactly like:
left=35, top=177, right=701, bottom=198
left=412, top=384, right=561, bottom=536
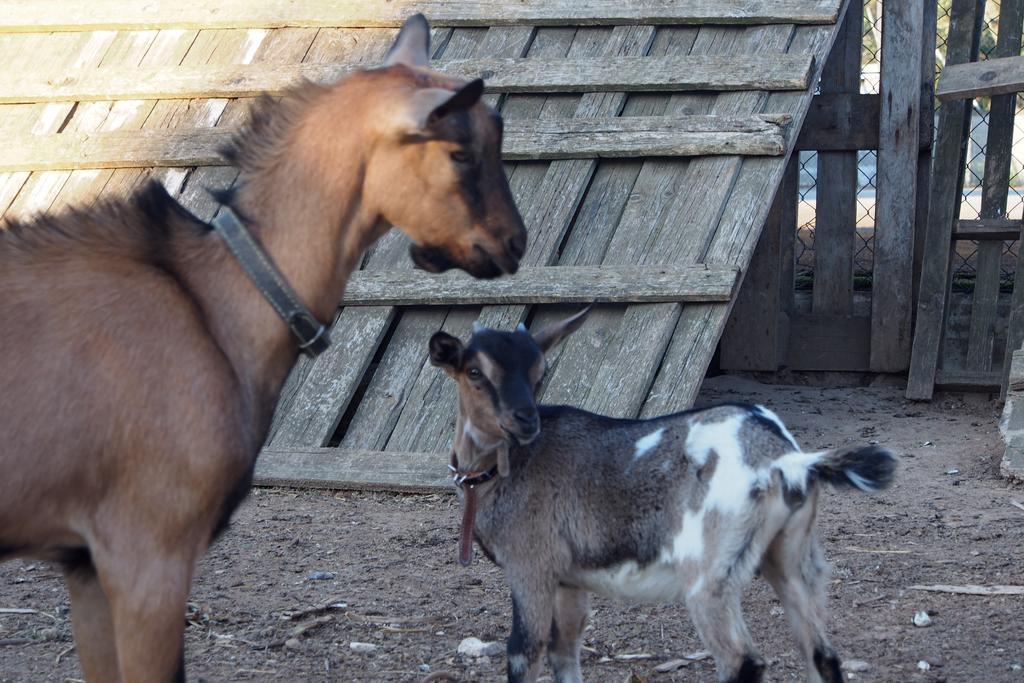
left=0, top=0, right=840, bottom=33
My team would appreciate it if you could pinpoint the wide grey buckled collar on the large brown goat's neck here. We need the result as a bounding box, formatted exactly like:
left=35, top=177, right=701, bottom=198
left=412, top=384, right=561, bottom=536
left=213, top=206, right=331, bottom=356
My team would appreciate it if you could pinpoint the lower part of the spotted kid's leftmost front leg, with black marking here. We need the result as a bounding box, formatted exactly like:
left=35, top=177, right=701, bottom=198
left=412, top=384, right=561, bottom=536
left=508, top=577, right=555, bottom=683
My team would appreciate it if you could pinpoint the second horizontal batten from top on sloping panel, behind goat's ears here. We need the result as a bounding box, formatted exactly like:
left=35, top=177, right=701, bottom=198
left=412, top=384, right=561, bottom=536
left=0, top=55, right=812, bottom=104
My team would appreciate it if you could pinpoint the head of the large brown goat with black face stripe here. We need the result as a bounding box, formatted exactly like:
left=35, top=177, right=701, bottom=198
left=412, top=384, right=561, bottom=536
left=364, top=14, right=526, bottom=278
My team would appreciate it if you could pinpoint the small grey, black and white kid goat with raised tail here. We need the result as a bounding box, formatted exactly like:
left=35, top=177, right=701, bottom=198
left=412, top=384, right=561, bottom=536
left=430, top=311, right=896, bottom=683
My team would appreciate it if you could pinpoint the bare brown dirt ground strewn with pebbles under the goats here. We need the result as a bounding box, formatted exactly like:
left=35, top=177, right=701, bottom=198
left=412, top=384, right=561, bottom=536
left=0, top=377, right=1024, bottom=683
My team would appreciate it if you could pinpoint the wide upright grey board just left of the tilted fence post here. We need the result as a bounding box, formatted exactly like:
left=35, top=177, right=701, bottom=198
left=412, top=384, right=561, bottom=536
left=870, top=0, right=925, bottom=372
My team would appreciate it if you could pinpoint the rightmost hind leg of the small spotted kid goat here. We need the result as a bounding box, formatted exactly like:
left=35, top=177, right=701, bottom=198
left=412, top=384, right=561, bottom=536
left=761, top=499, right=843, bottom=683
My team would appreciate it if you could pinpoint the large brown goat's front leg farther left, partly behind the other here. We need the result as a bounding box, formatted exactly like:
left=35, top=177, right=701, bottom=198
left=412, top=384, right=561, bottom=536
left=63, top=562, right=121, bottom=682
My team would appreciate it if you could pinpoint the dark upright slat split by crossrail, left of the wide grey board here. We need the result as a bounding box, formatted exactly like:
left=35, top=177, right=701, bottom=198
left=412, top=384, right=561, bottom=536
left=812, top=1, right=864, bottom=315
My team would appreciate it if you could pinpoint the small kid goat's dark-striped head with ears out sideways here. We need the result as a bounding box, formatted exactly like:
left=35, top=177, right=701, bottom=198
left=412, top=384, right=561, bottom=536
left=430, top=308, right=590, bottom=475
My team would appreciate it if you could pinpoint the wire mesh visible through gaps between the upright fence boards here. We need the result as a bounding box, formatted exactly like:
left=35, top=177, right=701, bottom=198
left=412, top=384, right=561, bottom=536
left=795, top=0, right=1024, bottom=291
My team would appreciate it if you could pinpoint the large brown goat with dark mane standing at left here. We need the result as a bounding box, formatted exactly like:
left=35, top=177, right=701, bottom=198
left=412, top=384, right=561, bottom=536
left=0, top=15, right=525, bottom=682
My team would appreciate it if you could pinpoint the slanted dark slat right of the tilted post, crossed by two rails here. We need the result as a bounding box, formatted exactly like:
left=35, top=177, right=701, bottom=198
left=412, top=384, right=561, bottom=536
left=966, top=0, right=1024, bottom=370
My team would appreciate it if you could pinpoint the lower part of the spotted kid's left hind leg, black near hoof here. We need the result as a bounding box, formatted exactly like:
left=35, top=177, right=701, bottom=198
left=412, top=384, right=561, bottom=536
left=686, top=578, right=765, bottom=683
